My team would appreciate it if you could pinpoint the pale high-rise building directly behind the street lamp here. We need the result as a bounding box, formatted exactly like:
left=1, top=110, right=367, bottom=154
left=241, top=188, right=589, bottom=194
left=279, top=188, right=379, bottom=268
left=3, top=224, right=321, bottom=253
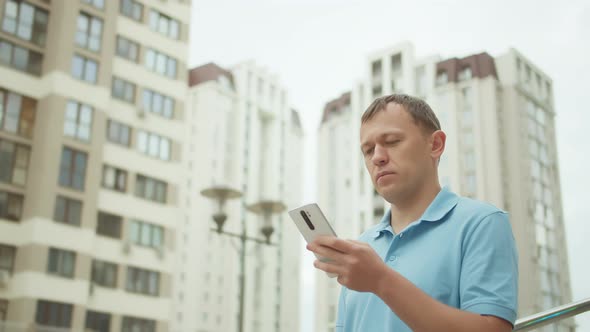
left=184, top=62, right=303, bottom=332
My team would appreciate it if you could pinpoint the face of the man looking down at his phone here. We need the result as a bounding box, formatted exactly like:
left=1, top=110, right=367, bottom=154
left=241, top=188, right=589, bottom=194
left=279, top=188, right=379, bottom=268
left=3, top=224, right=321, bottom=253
left=360, top=103, right=435, bottom=203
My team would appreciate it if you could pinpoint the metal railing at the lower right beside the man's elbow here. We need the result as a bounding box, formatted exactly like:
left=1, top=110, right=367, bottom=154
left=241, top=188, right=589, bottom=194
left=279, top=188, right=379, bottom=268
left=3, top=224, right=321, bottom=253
left=513, top=297, right=590, bottom=331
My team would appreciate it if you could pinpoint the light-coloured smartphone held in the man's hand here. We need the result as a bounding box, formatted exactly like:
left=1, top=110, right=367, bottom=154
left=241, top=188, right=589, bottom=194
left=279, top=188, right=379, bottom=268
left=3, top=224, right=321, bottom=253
left=289, top=203, right=338, bottom=278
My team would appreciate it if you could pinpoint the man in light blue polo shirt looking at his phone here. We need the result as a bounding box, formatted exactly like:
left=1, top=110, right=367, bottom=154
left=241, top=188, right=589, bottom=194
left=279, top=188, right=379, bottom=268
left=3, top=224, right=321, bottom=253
left=308, top=94, right=518, bottom=332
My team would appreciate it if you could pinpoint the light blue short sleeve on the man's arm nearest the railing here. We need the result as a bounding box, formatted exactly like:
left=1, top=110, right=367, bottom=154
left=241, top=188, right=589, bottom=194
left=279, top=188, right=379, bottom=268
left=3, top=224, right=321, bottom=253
left=460, top=211, right=518, bottom=326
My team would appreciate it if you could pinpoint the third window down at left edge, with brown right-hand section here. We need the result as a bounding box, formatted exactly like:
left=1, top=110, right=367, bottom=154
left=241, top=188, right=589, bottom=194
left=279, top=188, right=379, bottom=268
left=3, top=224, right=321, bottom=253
left=0, top=89, right=37, bottom=138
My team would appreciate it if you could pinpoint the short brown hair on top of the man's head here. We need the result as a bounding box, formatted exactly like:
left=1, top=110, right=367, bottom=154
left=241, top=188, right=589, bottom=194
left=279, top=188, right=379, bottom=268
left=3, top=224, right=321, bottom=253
left=361, top=94, right=440, bottom=134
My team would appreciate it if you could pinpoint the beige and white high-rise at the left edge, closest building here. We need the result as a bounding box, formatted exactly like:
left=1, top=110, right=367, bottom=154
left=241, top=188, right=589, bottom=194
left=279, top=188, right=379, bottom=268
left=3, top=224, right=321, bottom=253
left=0, top=0, right=190, bottom=332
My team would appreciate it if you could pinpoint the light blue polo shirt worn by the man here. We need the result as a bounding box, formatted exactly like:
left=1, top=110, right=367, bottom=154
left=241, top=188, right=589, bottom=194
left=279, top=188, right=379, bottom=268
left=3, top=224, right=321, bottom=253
left=336, top=188, right=518, bottom=332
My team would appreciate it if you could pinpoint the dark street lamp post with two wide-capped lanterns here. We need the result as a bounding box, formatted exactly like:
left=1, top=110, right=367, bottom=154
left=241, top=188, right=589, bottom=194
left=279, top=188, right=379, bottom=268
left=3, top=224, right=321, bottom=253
left=201, top=186, right=286, bottom=332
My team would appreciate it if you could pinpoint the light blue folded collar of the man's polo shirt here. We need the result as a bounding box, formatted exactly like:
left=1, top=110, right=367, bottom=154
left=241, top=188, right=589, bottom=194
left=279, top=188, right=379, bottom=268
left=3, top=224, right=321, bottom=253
left=373, top=187, right=459, bottom=239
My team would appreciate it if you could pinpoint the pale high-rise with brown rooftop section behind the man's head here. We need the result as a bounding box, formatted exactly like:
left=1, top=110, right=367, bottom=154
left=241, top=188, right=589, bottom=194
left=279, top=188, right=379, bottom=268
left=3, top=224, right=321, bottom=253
left=316, top=43, right=574, bottom=331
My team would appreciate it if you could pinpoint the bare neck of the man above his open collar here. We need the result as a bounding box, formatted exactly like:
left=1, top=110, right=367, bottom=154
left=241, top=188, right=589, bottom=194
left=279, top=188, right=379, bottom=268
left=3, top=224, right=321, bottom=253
left=390, top=183, right=441, bottom=234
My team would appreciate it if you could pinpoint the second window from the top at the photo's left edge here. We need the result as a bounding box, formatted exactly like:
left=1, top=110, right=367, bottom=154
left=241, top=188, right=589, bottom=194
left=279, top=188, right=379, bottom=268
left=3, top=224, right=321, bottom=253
left=0, top=39, right=43, bottom=75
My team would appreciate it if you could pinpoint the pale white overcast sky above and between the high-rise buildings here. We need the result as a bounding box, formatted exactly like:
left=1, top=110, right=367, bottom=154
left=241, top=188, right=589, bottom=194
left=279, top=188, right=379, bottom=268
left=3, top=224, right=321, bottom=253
left=189, top=0, right=590, bottom=332
